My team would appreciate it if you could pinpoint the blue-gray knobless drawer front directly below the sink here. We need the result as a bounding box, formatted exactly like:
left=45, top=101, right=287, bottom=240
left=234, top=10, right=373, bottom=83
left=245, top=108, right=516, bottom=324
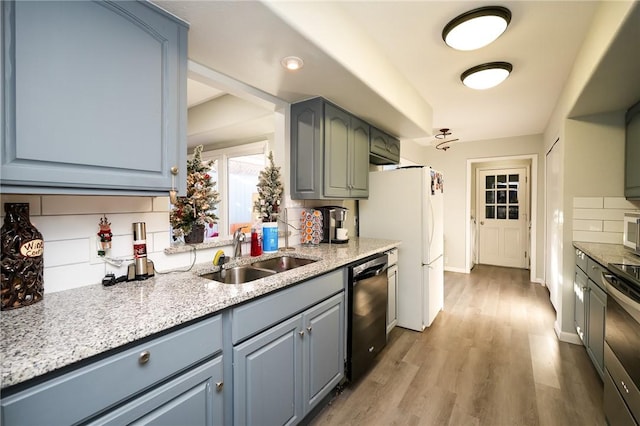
left=231, top=269, right=345, bottom=344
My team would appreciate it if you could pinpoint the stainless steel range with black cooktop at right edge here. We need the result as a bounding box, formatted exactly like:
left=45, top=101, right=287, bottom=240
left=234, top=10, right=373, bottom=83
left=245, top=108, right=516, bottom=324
left=602, top=263, right=640, bottom=425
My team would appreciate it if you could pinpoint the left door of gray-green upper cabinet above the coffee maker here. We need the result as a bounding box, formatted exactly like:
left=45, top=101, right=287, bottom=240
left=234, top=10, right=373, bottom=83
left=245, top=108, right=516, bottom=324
left=324, top=104, right=352, bottom=198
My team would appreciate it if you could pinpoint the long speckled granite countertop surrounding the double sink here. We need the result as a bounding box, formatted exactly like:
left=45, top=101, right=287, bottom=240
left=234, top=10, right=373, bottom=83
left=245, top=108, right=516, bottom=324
left=0, top=238, right=400, bottom=389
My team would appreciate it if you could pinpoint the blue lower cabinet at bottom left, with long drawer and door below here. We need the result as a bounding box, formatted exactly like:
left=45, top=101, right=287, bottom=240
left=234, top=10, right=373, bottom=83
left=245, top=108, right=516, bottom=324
left=0, top=316, right=224, bottom=426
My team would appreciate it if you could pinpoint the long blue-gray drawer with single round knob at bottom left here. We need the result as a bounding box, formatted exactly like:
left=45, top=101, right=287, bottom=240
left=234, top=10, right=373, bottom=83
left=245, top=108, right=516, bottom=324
left=2, top=316, right=222, bottom=425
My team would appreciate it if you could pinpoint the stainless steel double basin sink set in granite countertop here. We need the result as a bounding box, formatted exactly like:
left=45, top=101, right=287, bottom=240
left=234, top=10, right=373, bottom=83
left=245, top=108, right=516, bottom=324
left=200, top=256, right=317, bottom=284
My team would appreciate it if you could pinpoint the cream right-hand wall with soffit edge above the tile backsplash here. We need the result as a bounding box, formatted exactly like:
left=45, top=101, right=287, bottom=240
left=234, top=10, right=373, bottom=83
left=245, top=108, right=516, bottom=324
left=544, top=1, right=634, bottom=341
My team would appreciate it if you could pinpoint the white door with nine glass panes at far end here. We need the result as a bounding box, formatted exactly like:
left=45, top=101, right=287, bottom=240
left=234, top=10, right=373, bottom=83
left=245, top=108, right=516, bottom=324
left=476, top=167, right=529, bottom=269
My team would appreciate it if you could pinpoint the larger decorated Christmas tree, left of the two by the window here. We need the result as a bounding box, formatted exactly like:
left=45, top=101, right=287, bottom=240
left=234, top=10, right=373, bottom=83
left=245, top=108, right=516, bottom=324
left=170, top=145, right=220, bottom=239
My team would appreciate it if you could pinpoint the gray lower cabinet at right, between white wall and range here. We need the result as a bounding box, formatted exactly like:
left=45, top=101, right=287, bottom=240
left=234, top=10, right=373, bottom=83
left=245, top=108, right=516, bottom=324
left=573, top=249, right=607, bottom=378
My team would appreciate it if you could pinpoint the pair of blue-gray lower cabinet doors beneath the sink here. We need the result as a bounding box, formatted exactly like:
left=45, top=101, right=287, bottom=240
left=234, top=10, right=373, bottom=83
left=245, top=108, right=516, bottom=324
left=233, top=292, right=345, bottom=425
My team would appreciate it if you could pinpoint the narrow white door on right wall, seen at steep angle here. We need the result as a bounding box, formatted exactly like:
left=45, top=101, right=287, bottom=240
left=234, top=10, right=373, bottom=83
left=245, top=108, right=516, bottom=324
left=544, top=142, right=562, bottom=311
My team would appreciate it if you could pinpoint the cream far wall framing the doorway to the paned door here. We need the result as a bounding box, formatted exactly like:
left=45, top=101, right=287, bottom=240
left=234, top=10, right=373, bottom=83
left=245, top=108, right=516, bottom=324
left=401, top=135, right=544, bottom=279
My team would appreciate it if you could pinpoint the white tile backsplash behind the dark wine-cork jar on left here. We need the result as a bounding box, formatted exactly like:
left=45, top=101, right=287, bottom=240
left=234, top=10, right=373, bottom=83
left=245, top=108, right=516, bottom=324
left=1, top=194, right=230, bottom=293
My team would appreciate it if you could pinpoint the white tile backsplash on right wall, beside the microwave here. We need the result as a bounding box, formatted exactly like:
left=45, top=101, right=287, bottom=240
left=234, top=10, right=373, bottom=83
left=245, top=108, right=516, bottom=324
left=573, top=197, right=640, bottom=244
